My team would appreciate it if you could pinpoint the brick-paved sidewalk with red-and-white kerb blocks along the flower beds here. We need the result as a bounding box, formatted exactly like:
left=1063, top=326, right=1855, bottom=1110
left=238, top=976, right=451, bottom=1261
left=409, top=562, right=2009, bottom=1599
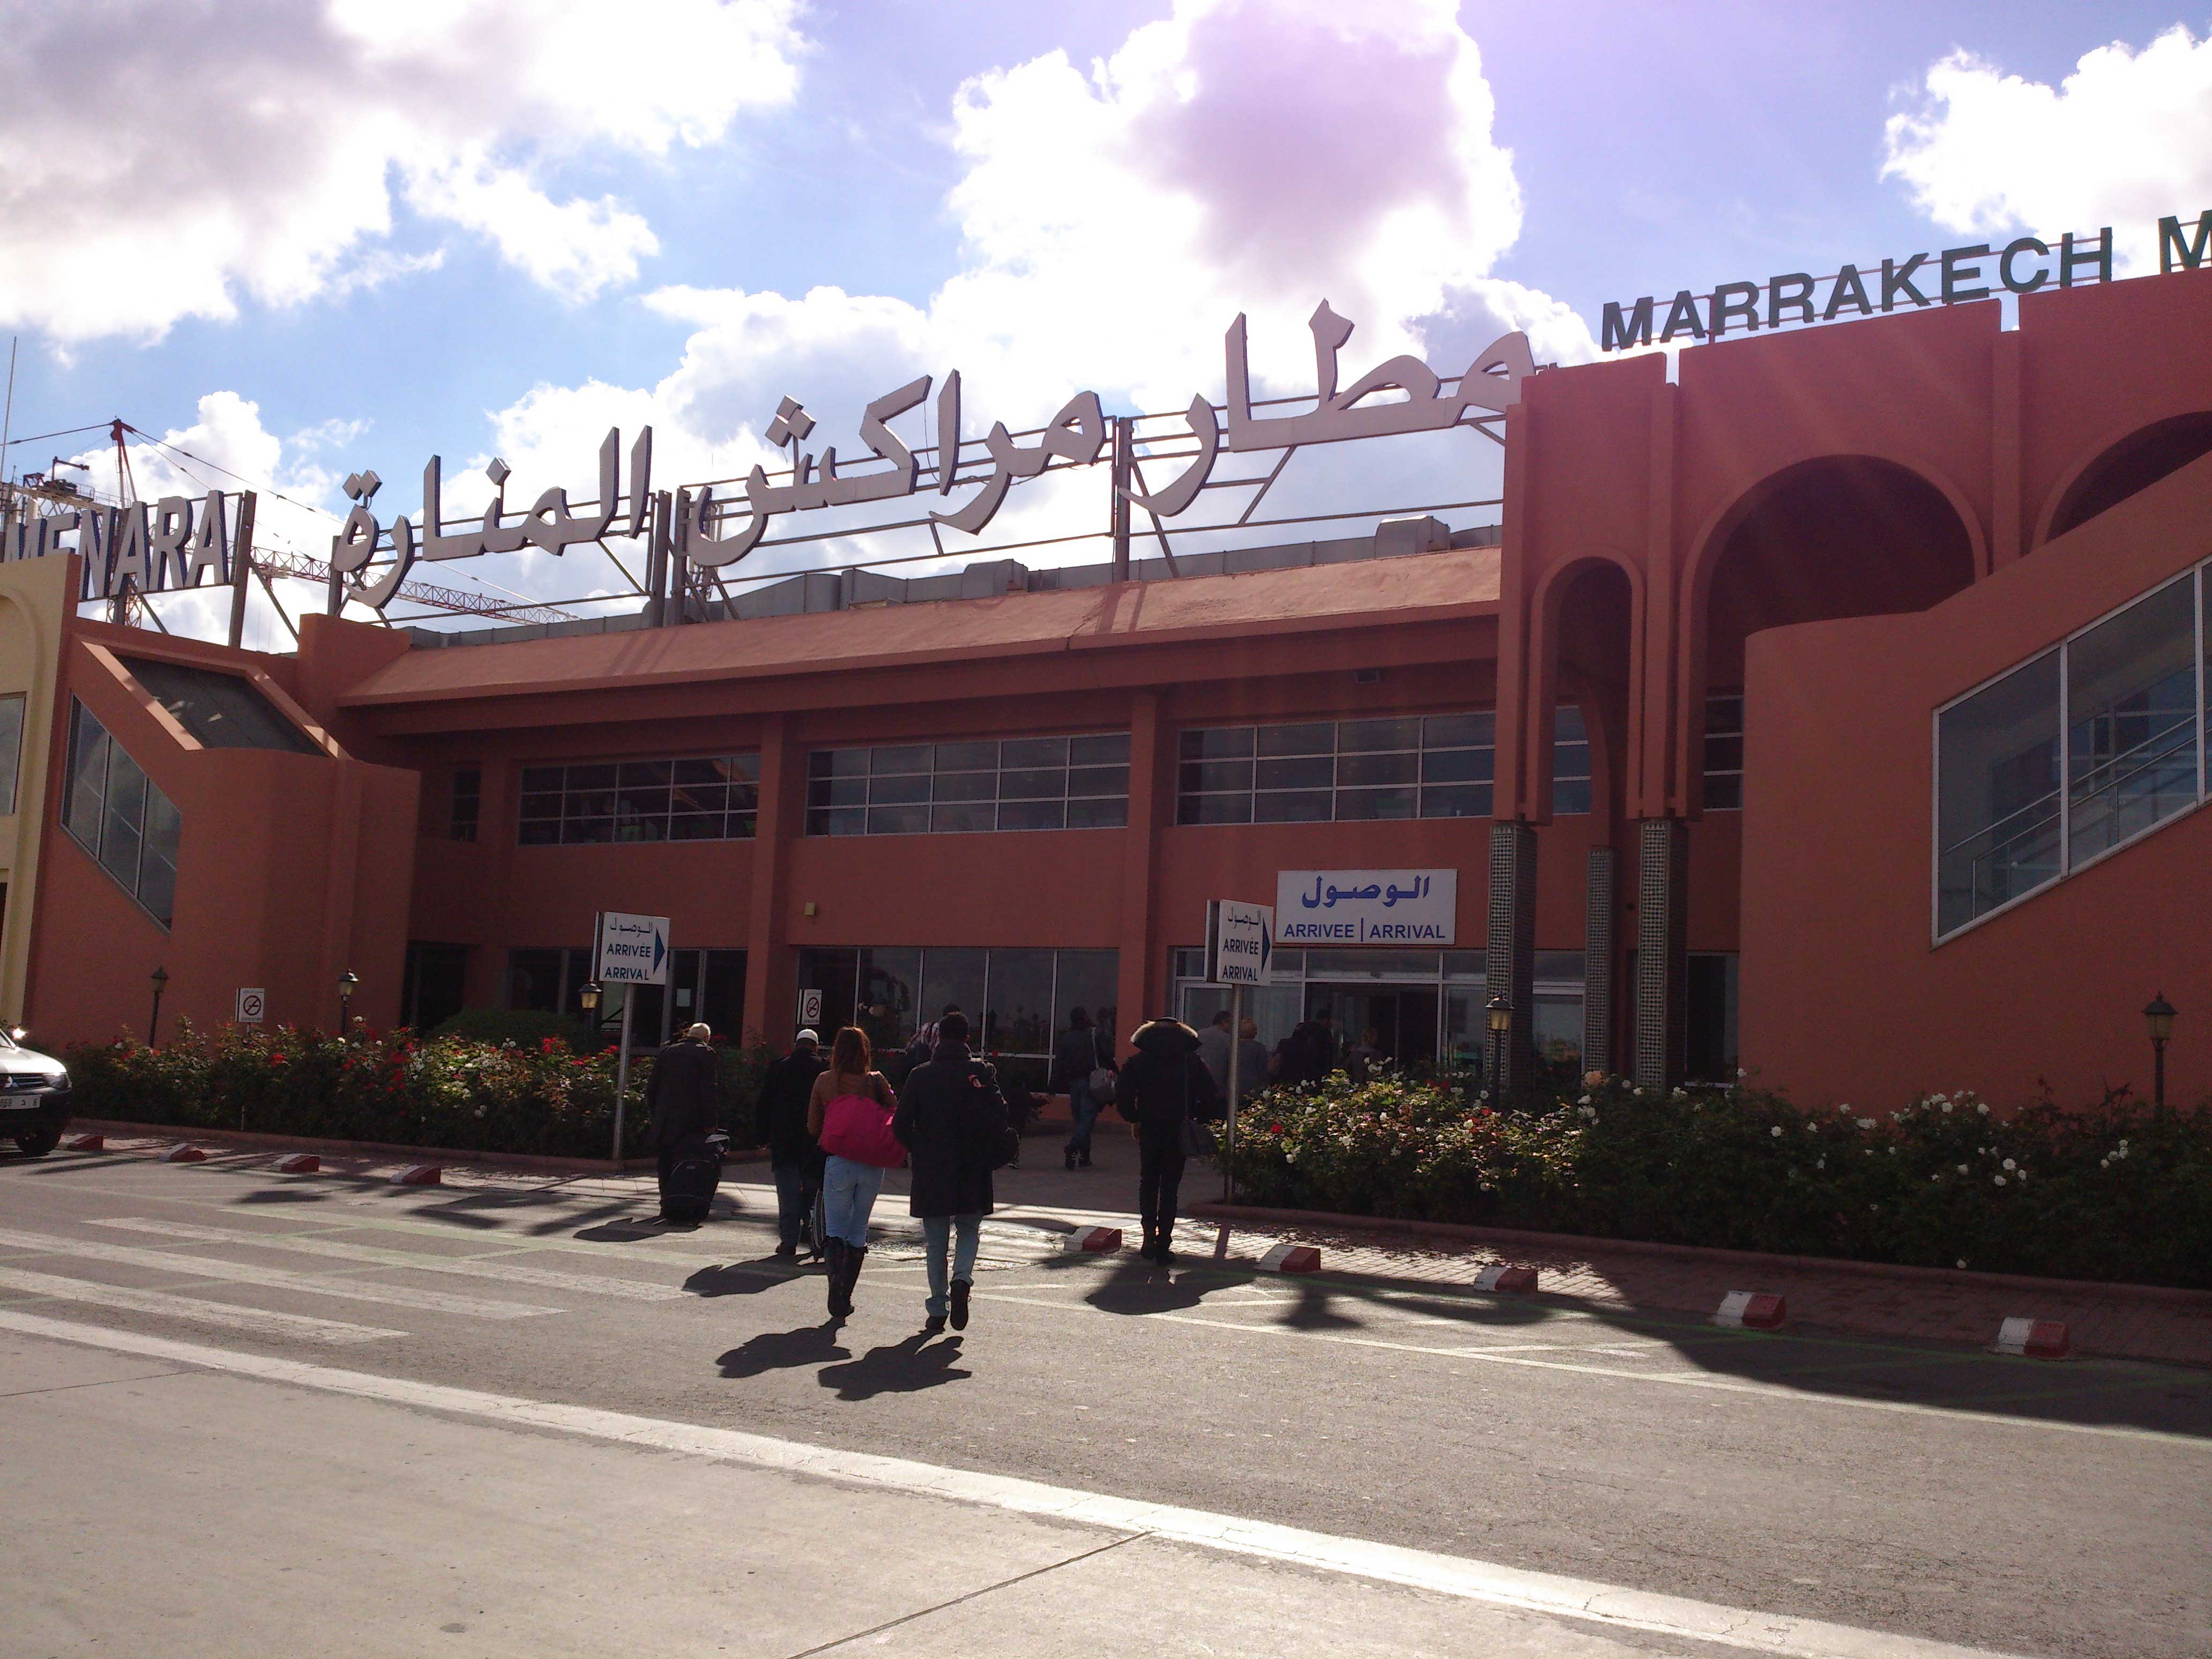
left=53, top=1119, right=2212, bottom=1367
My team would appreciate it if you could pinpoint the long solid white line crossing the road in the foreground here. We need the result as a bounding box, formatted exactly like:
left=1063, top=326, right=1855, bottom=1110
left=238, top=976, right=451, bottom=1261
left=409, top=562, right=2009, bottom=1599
left=0, top=1310, right=2026, bottom=1659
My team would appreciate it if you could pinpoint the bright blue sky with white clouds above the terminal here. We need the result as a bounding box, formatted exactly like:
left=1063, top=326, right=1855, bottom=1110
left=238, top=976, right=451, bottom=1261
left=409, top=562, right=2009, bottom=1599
left=0, top=0, right=2212, bottom=644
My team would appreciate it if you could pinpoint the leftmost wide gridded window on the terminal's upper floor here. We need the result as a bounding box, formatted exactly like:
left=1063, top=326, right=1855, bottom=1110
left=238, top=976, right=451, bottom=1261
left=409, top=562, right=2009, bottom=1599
left=517, top=750, right=761, bottom=847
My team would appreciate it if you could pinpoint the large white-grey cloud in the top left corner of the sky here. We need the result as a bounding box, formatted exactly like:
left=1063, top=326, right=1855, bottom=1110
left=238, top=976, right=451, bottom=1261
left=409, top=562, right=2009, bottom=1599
left=0, top=0, right=803, bottom=343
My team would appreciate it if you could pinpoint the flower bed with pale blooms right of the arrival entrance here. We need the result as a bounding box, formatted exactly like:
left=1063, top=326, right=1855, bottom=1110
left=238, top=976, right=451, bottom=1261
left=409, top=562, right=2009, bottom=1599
left=1237, top=1075, right=2212, bottom=1287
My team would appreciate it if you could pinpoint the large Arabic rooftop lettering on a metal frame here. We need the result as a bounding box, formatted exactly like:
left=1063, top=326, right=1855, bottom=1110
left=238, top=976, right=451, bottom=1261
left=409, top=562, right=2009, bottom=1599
left=330, top=301, right=1535, bottom=610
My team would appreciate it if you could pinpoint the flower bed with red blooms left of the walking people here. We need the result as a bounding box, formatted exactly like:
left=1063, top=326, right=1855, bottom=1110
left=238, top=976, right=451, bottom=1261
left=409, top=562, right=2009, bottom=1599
left=62, top=1022, right=763, bottom=1157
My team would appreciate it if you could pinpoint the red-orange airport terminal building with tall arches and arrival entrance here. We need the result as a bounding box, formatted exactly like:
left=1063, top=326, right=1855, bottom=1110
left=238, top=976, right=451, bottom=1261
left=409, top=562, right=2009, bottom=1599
left=0, top=270, right=2212, bottom=1106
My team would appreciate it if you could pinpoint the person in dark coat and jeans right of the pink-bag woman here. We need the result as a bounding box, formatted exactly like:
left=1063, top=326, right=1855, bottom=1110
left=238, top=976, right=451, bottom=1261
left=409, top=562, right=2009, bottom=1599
left=892, top=1011, right=1006, bottom=1332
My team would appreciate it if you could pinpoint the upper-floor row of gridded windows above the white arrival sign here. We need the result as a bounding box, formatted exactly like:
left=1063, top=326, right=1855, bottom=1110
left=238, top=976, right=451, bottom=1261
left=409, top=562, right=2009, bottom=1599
left=1175, top=708, right=1590, bottom=823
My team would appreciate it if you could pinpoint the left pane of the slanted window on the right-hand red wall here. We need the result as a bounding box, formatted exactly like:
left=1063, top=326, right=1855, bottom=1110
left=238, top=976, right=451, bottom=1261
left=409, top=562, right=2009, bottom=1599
left=1935, top=651, right=2059, bottom=933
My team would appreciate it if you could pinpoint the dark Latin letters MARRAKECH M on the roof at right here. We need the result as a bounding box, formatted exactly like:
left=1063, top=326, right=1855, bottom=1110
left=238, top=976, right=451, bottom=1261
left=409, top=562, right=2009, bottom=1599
left=1600, top=212, right=2212, bottom=352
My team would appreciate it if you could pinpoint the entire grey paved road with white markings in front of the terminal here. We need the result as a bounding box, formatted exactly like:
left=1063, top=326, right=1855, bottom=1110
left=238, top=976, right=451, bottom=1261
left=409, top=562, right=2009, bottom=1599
left=0, top=1148, right=2212, bottom=1659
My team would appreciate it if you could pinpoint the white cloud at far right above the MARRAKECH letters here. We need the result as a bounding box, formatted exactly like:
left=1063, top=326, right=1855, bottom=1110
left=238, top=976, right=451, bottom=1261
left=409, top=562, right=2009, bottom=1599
left=1882, top=27, right=2212, bottom=270
